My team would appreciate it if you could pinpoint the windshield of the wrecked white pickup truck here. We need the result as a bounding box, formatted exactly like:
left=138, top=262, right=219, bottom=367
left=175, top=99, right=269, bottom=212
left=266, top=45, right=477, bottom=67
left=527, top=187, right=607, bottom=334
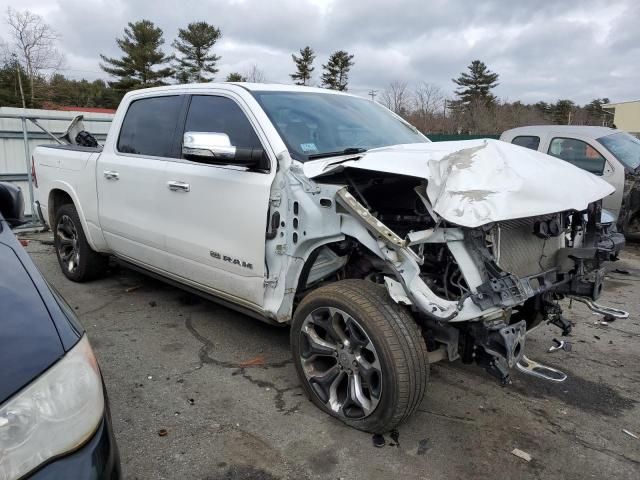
left=252, top=92, right=429, bottom=162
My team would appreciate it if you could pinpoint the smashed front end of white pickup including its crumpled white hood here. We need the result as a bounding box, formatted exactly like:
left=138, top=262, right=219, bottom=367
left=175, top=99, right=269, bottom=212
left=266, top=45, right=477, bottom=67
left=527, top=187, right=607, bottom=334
left=303, top=140, right=624, bottom=382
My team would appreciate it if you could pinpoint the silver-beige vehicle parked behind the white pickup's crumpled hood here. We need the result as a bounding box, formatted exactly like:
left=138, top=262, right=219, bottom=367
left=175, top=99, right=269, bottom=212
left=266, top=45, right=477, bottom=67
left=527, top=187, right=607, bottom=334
left=500, top=125, right=640, bottom=235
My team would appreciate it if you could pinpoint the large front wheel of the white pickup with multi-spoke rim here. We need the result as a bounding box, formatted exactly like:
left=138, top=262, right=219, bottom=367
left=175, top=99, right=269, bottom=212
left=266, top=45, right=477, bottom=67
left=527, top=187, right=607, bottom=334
left=291, top=280, right=429, bottom=433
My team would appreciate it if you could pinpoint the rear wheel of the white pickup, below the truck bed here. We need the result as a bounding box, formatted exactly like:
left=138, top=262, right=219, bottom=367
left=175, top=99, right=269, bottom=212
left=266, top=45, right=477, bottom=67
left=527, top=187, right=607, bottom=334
left=53, top=203, right=109, bottom=282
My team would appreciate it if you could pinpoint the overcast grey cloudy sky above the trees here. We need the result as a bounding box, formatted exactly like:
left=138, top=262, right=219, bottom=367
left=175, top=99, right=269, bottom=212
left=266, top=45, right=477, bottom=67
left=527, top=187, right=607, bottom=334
left=0, top=0, right=640, bottom=104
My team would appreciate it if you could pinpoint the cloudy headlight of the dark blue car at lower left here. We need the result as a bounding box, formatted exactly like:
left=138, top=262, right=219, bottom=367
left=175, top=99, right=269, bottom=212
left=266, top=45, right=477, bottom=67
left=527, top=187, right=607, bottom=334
left=0, top=335, right=104, bottom=480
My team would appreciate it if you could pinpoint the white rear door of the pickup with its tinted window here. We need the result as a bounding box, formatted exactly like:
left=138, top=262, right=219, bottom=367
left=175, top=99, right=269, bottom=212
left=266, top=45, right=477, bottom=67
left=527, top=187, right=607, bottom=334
left=96, top=95, right=187, bottom=270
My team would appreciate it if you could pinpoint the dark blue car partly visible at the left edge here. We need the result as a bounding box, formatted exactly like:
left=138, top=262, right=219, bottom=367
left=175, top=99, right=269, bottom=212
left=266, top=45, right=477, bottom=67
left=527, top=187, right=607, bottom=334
left=0, top=183, right=120, bottom=480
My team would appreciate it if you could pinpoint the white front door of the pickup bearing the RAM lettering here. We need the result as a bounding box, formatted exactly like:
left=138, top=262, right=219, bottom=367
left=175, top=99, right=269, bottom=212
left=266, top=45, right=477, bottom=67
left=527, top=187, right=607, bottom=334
left=159, top=94, right=275, bottom=310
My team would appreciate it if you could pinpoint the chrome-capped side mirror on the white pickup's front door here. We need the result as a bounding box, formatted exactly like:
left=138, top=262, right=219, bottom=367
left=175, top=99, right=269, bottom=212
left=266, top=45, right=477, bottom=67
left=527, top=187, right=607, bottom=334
left=182, top=132, right=269, bottom=169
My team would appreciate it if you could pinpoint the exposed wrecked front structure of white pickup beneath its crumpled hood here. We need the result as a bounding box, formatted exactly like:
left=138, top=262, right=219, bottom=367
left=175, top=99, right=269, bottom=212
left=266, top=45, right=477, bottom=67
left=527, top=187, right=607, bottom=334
left=336, top=179, right=624, bottom=383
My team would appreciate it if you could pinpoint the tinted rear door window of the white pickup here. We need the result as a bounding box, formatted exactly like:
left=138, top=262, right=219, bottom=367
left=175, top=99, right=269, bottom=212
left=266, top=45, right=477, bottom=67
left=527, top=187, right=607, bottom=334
left=118, top=95, right=183, bottom=157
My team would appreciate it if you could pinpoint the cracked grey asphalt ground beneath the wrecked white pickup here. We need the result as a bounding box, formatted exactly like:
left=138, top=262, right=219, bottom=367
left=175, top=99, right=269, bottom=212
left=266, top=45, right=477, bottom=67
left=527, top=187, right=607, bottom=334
left=23, top=235, right=640, bottom=480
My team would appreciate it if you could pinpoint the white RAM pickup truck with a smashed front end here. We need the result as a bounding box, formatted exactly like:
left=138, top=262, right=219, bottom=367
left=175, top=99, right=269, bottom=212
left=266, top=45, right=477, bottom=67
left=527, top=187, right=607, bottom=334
left=33, top=83, right=624, bottom=432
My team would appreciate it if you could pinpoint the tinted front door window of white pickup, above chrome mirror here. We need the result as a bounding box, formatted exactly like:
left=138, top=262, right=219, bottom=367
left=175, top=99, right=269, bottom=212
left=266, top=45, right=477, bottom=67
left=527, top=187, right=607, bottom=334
left=184, top=95, right=262, bottom=153
